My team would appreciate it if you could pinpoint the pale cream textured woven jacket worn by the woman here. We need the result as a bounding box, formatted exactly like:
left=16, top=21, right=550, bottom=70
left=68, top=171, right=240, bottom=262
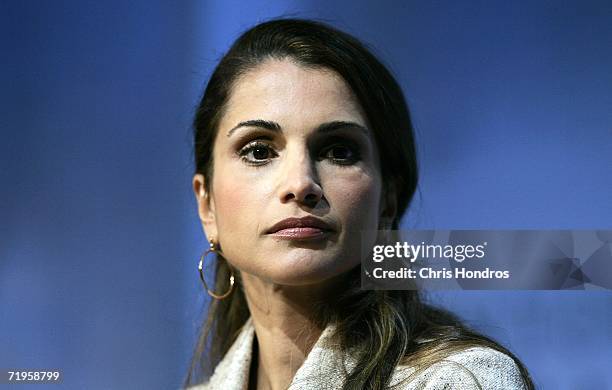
left=190, top=319, right=525, bottom=390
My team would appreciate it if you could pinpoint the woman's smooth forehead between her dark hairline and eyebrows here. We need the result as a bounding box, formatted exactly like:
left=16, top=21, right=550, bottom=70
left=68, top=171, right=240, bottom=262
left=221, top=59, right=366, bottom=129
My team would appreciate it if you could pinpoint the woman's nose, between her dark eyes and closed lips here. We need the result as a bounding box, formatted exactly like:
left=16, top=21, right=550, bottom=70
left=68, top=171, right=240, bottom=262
left=279, top=152, right=323, bottom=208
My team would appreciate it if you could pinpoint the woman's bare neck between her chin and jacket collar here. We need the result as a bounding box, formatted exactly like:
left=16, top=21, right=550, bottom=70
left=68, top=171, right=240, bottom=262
left=242, top=273, right=340, bottom=390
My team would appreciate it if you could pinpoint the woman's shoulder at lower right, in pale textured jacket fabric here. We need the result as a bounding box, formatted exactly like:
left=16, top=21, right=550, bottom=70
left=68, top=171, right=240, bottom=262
left=391, top=347, right=526, bottom=390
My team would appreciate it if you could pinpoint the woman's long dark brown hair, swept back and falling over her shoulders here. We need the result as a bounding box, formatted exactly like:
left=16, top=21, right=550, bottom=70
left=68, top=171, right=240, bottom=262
left=184, top=19, right=533, bottom=390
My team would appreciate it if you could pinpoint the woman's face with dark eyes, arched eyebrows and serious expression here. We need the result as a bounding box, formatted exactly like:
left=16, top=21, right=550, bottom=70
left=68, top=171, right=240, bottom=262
left=194, top=60, right=392, bottom=286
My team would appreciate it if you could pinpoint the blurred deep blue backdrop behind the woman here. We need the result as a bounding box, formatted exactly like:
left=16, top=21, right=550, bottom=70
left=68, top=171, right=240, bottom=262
left=0, top=0, right=612, bottom=389
